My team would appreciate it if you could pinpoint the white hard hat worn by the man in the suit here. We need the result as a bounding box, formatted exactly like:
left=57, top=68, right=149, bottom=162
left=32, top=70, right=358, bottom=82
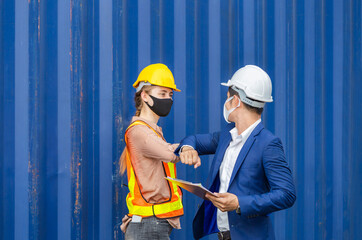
left=221, top=65, right=273, bottom=108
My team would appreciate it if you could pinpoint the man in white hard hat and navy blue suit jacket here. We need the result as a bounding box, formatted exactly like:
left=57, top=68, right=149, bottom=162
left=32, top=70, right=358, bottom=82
left=176, top=65, right=296, bottom=240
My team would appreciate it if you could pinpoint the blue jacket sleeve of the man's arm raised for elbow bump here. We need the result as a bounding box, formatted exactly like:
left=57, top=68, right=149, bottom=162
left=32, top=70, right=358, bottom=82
left=175, top=132, right=220, bottom=155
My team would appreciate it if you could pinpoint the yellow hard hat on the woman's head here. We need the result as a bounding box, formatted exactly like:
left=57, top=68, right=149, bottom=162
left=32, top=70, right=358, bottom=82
left=133, top=63, right=181, bottom=92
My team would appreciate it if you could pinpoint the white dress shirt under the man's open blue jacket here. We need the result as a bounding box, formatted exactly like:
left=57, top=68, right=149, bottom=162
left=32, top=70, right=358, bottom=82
left=217, top=119, right=261, bottom=232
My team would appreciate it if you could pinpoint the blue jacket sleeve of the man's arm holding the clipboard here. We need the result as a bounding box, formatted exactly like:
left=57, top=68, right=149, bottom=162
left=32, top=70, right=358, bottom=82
left=238, top=138, right=296, bottom=217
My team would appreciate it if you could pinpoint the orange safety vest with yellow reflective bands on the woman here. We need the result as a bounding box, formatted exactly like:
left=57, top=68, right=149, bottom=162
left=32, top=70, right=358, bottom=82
left=125, top=120, right=184, bottom=218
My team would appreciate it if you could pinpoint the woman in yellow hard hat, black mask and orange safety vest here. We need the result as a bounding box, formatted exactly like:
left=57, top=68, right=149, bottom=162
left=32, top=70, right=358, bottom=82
left=120, top=64, right=189, bottom=239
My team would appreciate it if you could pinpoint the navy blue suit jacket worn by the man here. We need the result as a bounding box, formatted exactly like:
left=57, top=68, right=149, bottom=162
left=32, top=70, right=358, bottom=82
left=176, top=123, right=296, bottom=239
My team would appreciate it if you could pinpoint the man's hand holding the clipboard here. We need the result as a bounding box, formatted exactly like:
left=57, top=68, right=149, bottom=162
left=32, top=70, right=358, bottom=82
left=205, top=193, right=239, bottom=212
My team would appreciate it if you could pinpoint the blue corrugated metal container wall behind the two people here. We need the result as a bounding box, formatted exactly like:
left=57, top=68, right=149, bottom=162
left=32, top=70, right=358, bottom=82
left=0, top=0, right=362, bottom=240
